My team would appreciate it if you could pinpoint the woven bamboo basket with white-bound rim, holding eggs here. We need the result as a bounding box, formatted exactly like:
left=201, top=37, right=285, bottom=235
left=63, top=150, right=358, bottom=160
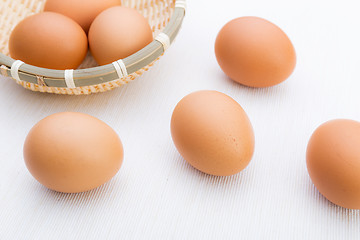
left=0, top=0, right=186, bottom=95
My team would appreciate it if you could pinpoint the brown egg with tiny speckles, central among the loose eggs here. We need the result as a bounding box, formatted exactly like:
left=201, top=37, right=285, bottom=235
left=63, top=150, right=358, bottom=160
left=171, top=91, right=254, bottom=176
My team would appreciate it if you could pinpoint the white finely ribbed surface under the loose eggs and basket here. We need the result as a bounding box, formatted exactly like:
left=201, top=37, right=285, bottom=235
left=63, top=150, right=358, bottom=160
left=0, top=0, right=360, bottom=239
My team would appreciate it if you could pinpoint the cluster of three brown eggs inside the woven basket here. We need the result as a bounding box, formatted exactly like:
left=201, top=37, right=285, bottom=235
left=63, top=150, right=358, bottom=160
left=9, top=0, right=153, bottom=70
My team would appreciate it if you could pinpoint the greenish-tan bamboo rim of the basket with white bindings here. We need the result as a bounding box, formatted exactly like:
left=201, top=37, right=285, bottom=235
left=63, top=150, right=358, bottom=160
left=0, top=0, right=186, bottom=88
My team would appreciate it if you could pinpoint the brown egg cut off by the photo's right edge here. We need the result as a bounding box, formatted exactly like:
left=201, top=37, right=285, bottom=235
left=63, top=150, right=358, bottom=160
left=306, top=119, right=360, bottom=209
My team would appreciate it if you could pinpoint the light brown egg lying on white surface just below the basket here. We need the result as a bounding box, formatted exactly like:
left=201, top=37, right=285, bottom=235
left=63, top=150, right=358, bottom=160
left=24, top=112, right=123, bottom=193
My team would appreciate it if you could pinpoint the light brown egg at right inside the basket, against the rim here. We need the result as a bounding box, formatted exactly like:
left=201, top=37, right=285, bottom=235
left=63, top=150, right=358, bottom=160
left=89, top=7, right=153, bottom=65
